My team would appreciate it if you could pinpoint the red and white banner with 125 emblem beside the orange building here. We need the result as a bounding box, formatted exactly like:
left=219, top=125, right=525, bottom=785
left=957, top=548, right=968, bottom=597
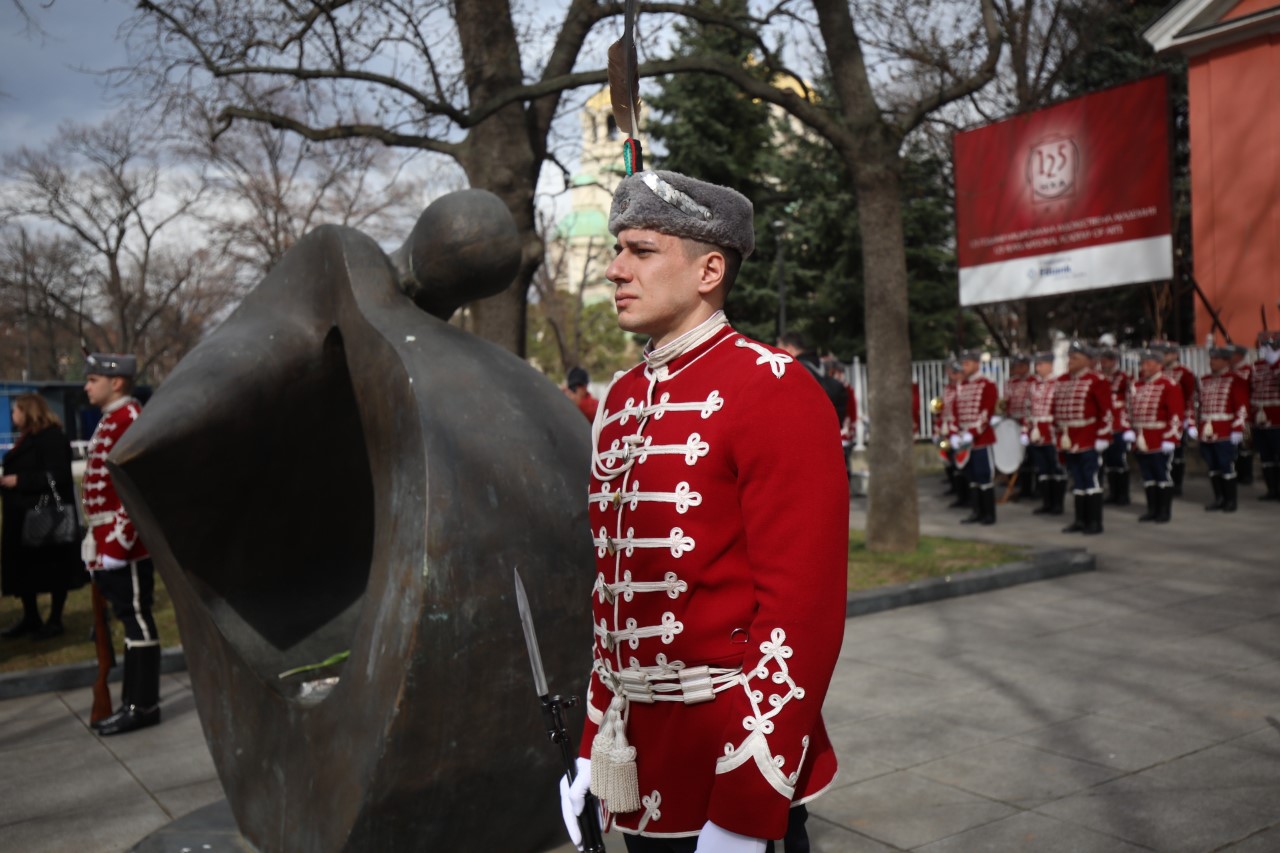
left=952, top=74, right=1172, bottom=305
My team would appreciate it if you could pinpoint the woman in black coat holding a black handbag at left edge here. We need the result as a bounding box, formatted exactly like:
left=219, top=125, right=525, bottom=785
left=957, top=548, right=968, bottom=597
left=0, top=394, right=87, bottom=639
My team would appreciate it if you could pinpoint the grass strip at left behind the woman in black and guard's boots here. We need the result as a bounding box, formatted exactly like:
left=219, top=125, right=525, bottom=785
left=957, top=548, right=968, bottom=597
left=0, top=573, right=182, bottom=672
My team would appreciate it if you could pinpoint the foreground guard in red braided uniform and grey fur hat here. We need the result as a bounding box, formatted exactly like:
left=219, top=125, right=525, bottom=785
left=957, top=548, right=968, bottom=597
left=562, top=172, right=849, bottom=853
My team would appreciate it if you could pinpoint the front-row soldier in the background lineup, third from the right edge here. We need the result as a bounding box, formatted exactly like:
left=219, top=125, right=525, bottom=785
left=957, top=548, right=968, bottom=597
left=1129, top=350, right=1187, bottom=524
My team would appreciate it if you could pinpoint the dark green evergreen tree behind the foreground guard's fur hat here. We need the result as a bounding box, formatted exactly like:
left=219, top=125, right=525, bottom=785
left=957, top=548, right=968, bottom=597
left=648, top=13, right=973, bottom=361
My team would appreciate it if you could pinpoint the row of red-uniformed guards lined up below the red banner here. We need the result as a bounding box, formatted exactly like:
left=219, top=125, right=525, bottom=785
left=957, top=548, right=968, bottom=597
left=931, top=326, right=1280, bottom=534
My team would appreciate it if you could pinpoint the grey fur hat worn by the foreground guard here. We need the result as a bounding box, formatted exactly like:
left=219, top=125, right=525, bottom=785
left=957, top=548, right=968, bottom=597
left=609, top=172, right=755, bottom=257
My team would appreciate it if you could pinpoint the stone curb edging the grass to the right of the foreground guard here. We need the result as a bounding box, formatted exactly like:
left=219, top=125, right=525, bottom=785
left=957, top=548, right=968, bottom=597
left=845, top=548, right=1097, bottom=619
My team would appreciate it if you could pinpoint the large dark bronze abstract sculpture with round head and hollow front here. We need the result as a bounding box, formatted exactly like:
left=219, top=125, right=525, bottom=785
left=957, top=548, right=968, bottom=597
left=110, top=191, right=591, bottom=850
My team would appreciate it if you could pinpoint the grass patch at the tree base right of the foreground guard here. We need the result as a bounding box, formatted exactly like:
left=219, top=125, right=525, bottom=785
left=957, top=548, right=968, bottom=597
left=849, top=530, right=1027, bottom=592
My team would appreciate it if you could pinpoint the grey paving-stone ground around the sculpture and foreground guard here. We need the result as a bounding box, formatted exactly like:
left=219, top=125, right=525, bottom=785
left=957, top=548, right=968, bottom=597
left=0, top=476, right=1280, bottom=853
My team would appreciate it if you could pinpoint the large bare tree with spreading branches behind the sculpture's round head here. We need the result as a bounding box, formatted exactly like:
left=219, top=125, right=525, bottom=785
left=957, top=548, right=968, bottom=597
left=131, top=0, right=634, bottom=352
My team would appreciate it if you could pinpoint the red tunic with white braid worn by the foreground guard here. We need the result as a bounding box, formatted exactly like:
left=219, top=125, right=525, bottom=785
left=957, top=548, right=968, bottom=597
left=580, top=325, right=849, bottom=839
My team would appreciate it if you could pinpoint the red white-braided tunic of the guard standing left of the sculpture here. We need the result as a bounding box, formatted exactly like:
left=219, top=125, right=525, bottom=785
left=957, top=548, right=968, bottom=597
left=81, top=397, right=147, bottom=571
